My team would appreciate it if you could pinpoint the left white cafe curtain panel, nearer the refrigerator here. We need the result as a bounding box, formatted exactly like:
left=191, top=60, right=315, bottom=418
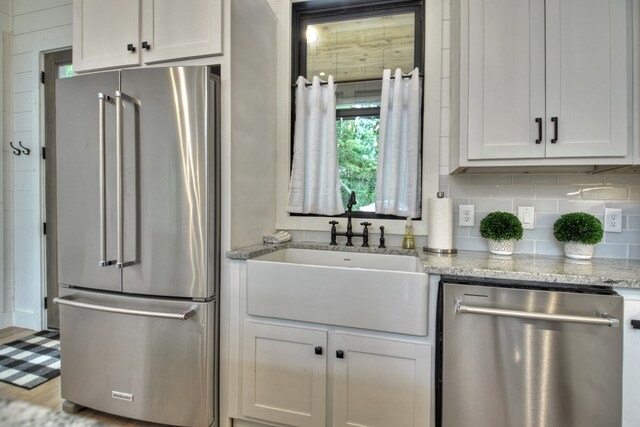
left=287, top=76, right=344, bottom=215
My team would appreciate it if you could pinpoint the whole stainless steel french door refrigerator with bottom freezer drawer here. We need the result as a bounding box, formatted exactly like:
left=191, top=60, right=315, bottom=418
left=51, top=67, right=220, bottom=426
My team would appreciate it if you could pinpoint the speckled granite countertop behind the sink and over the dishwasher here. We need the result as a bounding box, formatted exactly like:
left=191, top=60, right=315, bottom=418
left=227, top=242, right=640, bottom=288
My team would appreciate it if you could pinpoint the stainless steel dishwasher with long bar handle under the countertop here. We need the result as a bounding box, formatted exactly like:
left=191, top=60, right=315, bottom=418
left=436, top=278, right=623, bottom=427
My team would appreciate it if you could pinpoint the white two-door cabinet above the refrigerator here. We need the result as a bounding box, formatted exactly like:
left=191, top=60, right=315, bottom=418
left=73, top=0, right=222, bottom=71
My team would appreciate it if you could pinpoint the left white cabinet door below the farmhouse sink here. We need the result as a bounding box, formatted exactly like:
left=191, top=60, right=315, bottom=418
left=242, top=322, right=327, bottom=427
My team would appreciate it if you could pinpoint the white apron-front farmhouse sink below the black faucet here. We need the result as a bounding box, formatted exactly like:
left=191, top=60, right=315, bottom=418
left=247, top=248, right=428, bottom=336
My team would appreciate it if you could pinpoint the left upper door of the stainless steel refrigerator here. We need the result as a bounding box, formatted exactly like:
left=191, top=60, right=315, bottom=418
left=56, top=72, right=122, bottom=291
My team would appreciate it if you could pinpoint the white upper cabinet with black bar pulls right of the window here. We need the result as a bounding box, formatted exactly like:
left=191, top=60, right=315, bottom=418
left=451, top=0, right=632, bottom=169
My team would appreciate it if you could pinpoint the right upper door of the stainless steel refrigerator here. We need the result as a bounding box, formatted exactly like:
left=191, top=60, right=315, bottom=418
left=121, top=67, right=216, bottom=298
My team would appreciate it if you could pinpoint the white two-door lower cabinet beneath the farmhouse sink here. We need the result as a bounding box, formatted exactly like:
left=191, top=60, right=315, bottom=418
left=242, top=321, right=431, bottom=427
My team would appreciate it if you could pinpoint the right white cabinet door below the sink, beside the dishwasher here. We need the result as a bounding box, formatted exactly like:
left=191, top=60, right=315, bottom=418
left=331, top=333, right=431, bottom=427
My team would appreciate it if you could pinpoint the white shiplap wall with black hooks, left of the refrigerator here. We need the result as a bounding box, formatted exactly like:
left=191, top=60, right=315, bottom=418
left=3, top=0, right=72, bottom=329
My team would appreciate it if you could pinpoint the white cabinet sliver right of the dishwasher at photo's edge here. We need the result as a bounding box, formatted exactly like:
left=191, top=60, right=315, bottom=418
left=622, top=296, right=640, bottom=427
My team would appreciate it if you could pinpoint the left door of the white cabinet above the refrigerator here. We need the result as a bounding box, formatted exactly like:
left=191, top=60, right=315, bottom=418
left=73, top=0, right=140, bottom=71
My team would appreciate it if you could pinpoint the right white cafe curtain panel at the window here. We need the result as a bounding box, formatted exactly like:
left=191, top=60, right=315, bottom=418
left=376, top=68, right=421, bottom=218
